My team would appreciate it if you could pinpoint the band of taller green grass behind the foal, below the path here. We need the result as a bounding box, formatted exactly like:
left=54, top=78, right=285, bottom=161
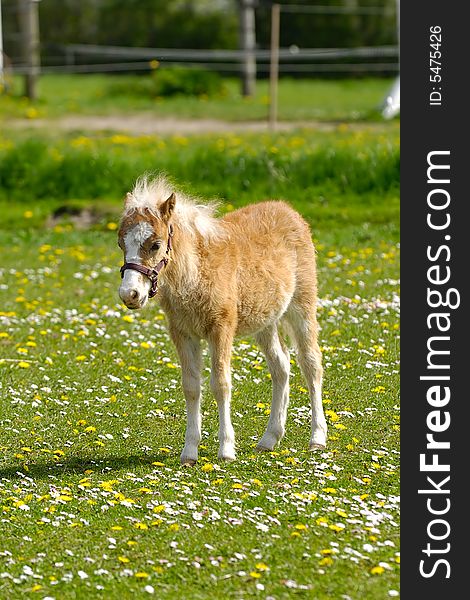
left=0, top=123, right=399, bottom=234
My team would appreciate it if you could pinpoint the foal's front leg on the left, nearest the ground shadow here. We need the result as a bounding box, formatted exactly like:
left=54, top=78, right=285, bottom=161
left=171, top=330, right=202, bottom=465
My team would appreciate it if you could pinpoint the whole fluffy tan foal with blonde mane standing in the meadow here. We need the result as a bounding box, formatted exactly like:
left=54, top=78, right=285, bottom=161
left=119, top=177, right=327, bottom=464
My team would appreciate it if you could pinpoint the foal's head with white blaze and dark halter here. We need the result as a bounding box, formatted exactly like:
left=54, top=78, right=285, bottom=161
left=118, top=193, right=176, bottom=309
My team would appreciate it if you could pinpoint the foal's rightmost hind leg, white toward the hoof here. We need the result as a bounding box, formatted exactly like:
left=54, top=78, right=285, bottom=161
left=286, top=307, right=327, bottom=450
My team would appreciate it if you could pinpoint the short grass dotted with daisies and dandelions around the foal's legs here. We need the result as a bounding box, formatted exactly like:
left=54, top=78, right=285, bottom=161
left=0, top=230, right=399, bottom=599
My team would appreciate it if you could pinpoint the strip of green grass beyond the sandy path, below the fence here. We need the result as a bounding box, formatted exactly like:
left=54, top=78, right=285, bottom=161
left=0, top=75, right=392, bottom=124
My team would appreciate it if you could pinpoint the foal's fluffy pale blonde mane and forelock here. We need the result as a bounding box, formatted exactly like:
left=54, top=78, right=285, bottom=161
left=123, top=175, right=223, bottom=240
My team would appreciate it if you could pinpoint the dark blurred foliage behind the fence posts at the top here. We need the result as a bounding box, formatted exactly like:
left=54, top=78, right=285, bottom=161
left=2, top=0, right=396, bottom=67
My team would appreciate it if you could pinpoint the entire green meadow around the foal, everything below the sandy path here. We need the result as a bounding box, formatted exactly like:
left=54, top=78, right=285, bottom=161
left=0, top=77, right=400, bottom=600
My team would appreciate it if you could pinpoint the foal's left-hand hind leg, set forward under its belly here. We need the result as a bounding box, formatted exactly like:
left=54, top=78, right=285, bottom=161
left=255, top=324, right=290, bottom=451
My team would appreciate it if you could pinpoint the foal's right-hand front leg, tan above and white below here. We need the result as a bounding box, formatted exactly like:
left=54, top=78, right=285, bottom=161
left=209, top=330, right=235, bottom=460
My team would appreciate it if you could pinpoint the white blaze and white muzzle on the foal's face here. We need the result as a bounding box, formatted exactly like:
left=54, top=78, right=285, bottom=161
left=119, top=221, right=153, bottom=304
